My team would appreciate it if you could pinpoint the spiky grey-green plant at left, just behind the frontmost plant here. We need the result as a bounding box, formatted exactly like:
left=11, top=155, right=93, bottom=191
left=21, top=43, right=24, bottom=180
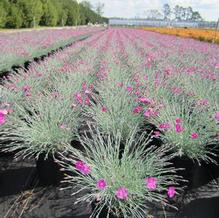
left=1, top=96, right=80, bottom=158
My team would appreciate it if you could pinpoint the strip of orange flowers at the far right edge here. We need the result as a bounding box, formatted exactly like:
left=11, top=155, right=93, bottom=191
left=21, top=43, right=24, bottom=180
left=143, top=27, right=219, bottom=44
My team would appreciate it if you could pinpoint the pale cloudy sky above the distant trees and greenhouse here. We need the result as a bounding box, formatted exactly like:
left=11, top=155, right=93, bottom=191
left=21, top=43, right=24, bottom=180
left=84, top=0, right=219, bottom=21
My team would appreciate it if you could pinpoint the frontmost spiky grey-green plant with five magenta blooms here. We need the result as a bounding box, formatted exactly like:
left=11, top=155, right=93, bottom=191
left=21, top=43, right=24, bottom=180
left=59, top=128, right=180, bottom=218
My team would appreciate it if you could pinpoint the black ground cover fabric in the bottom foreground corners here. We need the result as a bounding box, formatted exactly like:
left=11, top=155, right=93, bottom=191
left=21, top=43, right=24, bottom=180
left=0, top=155, right=219, bottom=218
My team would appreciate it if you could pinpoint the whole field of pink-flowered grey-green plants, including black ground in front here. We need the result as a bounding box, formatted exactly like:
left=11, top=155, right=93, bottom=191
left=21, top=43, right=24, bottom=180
left=0, top=28, right=219, bottom=218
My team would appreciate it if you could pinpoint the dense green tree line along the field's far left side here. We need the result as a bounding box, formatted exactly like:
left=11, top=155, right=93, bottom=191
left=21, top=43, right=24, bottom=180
left=0, top=0, right=107, bottom=28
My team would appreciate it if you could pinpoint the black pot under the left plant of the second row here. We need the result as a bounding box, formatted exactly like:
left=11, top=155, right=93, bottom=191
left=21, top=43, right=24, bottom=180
left=36, top=154, right=64, bottom=186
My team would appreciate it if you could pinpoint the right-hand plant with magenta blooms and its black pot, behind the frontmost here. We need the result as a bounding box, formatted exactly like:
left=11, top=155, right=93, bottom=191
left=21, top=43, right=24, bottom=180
left=150, top=97, right=218, bottom=189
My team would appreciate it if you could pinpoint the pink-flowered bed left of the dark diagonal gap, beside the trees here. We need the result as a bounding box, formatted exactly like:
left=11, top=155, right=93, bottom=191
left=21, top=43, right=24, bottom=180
left=0, top=27, right=101, bottom=72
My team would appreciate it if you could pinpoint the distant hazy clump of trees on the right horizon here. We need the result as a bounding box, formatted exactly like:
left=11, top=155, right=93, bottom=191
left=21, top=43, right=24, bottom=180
left=147, top=4, right=204, bottom=21
